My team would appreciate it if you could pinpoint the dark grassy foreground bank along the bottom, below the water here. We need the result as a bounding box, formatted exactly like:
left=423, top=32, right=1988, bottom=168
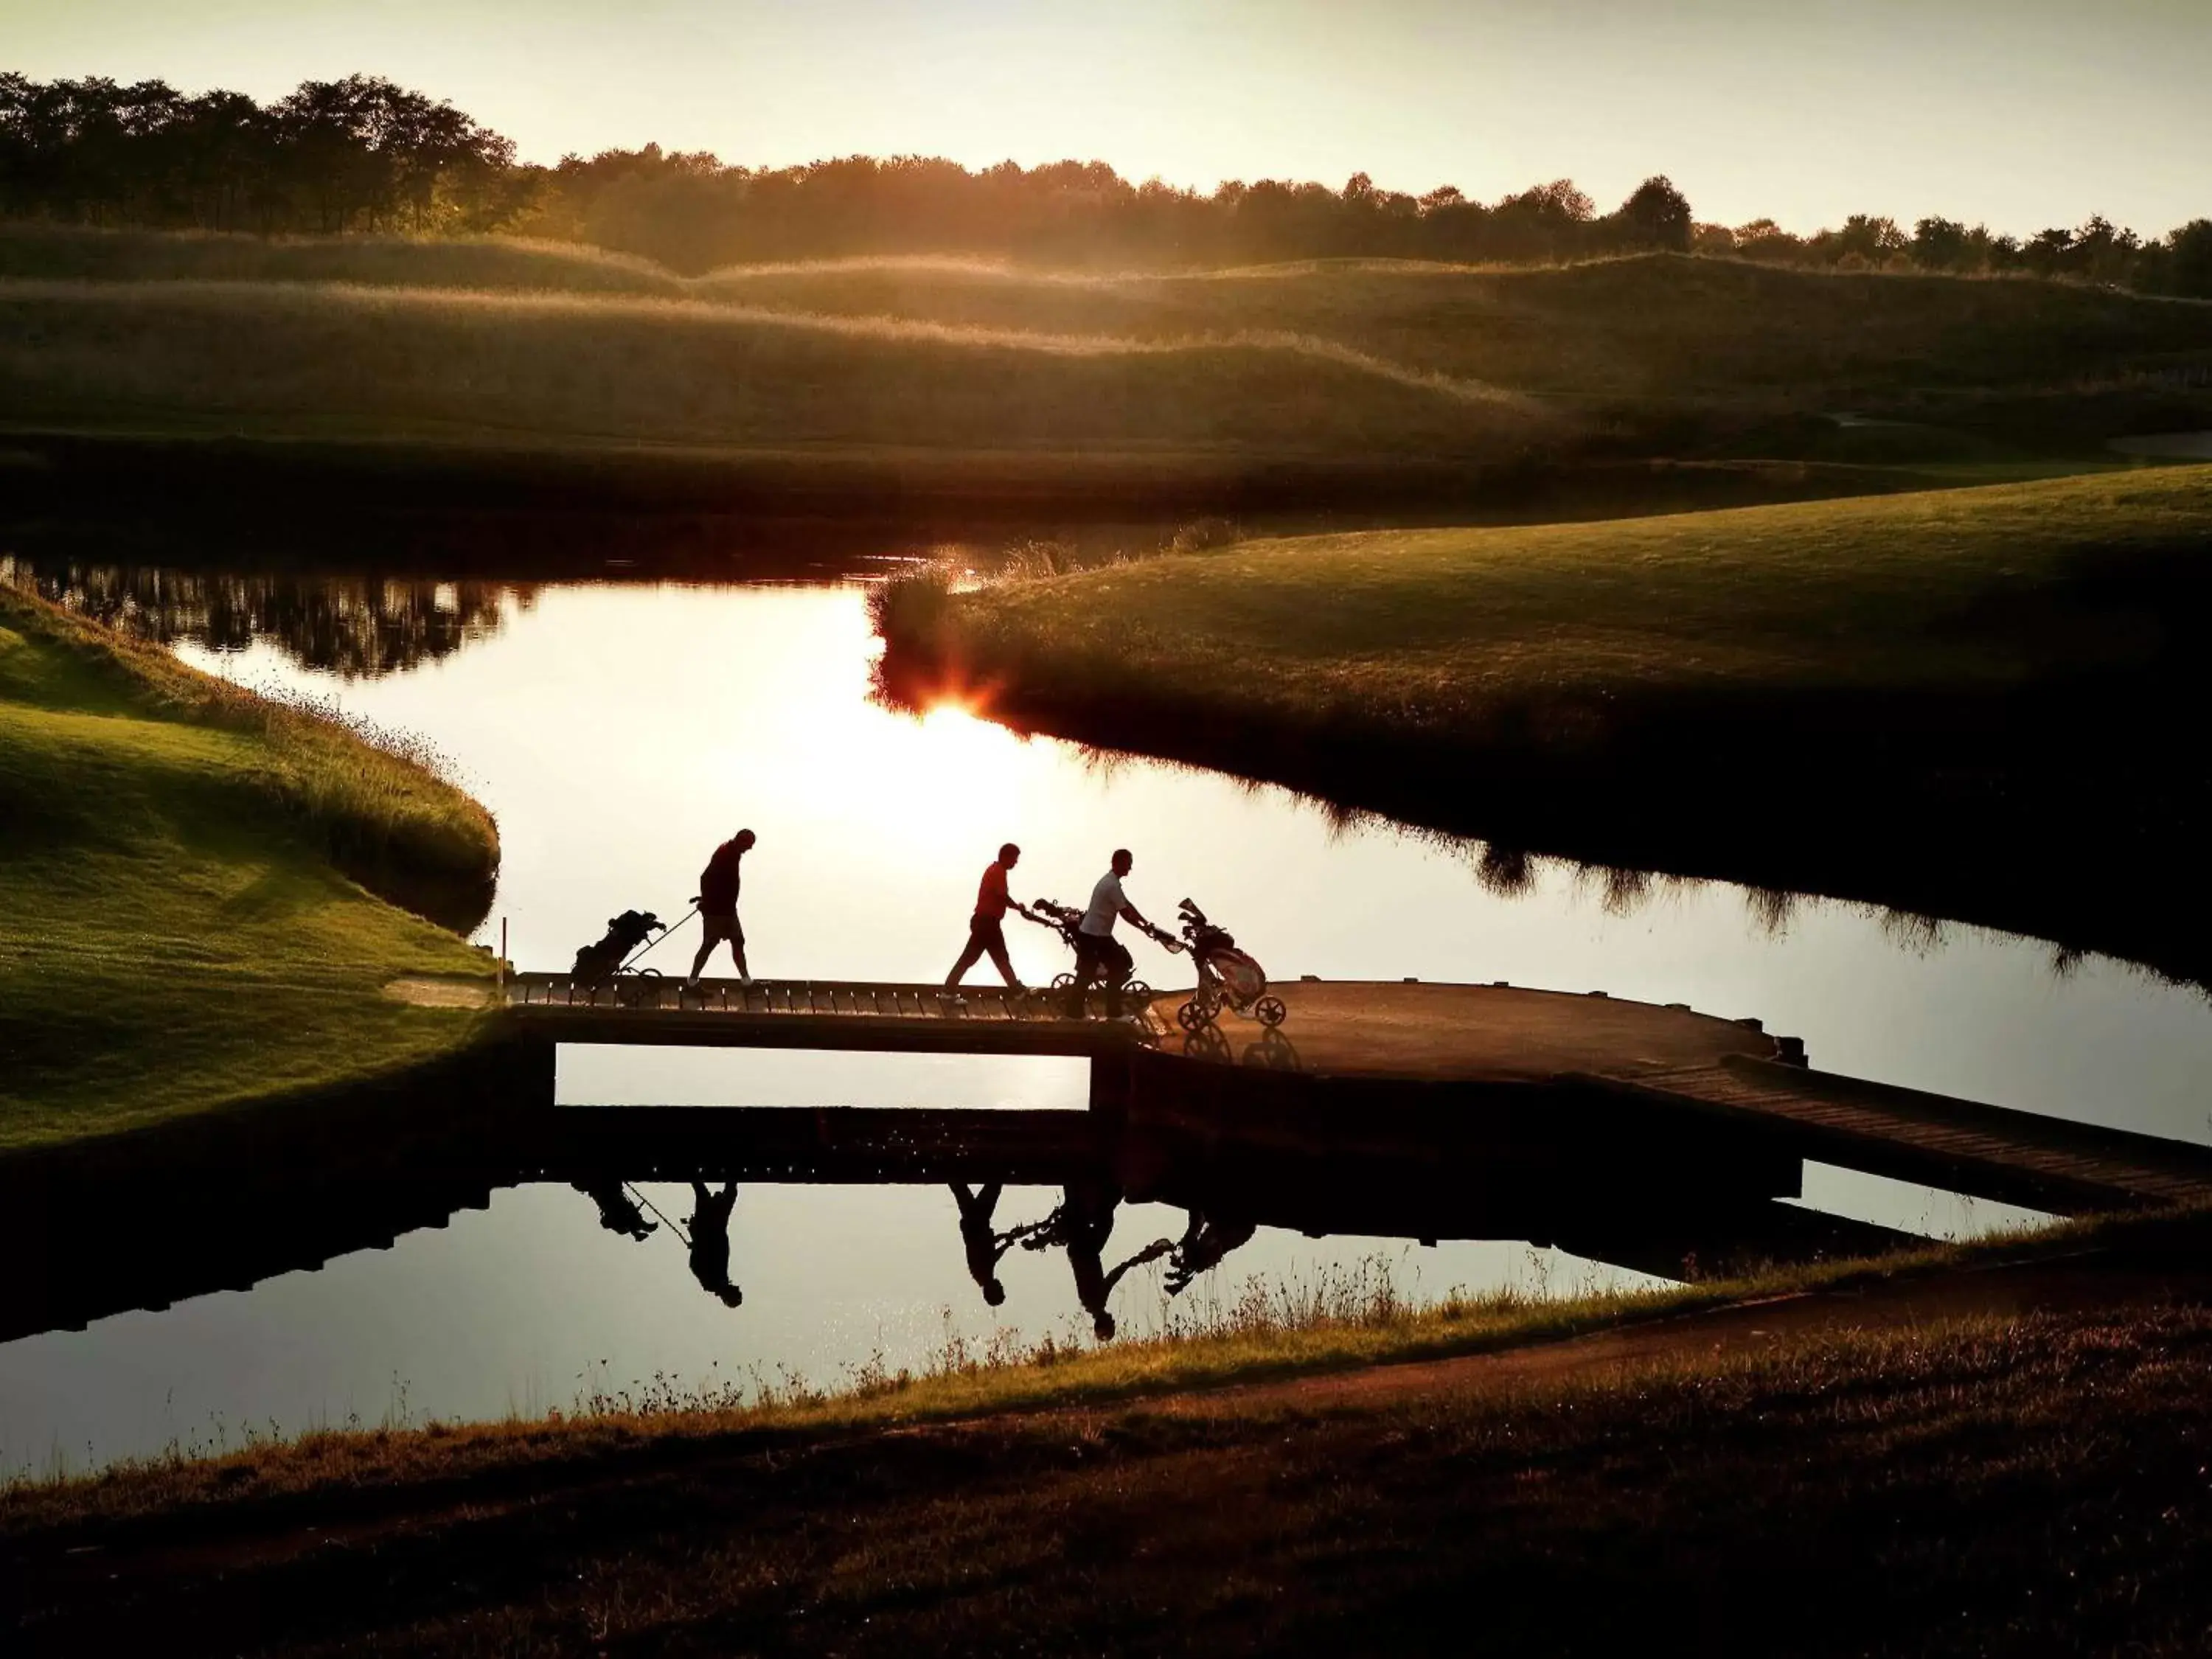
left=0, top=1223, right=2212, bottom=1652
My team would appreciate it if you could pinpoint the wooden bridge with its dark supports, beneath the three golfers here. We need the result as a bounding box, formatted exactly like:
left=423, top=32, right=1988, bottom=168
left=504, top=973, right=2212, bottom=1214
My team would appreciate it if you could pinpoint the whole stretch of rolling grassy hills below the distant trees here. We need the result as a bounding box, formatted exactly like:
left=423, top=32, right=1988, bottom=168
left=0, top=226, right=2212, bottom=489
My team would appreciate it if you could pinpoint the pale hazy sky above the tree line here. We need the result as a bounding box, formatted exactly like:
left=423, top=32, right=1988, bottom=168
left=0, top=0, right=2212, bottom=232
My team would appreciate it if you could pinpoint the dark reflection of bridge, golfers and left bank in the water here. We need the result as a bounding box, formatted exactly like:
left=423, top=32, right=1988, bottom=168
left=0, top=1057, right=1909, bottom=1340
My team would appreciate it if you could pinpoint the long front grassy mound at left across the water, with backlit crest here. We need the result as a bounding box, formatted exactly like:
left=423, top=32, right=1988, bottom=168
left=0, top=283, right=1551, bottom=462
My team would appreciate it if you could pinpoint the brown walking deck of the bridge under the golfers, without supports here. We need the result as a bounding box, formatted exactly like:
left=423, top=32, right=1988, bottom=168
left=507, top=973, right=2212, bottom=1212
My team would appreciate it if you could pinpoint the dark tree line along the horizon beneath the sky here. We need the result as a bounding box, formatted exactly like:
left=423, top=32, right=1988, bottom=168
left=0, top=75, right=2212, bottom=299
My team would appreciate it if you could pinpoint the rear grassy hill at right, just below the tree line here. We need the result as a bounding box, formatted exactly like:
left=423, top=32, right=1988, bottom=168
left=695, top=254, right=2212, bottom=416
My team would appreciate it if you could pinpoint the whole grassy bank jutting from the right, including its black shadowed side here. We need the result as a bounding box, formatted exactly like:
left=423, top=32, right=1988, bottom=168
left=878, top=467, right=2212, bottom=973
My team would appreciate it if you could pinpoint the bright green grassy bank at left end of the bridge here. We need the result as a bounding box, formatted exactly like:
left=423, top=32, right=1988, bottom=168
left=0, top=588, right=498, bottom=1150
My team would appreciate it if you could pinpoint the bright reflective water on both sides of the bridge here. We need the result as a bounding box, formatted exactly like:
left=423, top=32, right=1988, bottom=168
left=0, top=577, right=2212, bottom=1471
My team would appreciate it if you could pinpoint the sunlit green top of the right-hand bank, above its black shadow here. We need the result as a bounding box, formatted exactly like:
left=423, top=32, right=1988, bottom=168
left=911, top=467, right=2212, bottom=739
